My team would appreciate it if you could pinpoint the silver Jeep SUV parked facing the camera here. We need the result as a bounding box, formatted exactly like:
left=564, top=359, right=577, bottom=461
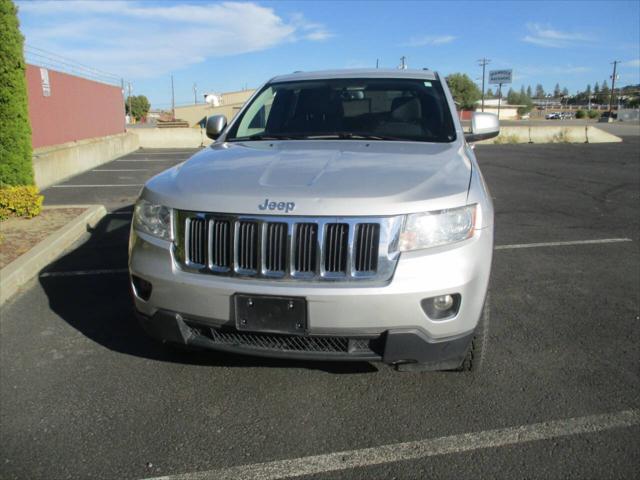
left=129, top=69, right=498, bottom=370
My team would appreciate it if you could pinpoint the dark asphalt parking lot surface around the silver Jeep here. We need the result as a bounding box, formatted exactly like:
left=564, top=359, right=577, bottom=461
left=0, top=136, right=640, bottom=480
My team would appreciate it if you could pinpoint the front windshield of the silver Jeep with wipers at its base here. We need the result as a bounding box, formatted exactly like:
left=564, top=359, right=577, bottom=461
left=226, top=79, right=456, bottom=142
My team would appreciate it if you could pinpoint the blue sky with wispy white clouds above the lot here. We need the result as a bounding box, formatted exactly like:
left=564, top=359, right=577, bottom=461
left=16, top=0, right=640, bottom=108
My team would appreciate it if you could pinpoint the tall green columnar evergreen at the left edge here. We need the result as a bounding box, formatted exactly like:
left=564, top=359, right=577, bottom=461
left=0, top=0, right=33, bottom=187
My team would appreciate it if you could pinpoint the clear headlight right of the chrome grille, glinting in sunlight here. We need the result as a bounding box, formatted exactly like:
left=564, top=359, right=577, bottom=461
left=400, top=204, right=477, bottom=252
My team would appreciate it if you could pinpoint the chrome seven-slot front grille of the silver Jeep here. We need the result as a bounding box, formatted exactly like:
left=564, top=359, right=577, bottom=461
left=175, top=211, right=402, bottom=281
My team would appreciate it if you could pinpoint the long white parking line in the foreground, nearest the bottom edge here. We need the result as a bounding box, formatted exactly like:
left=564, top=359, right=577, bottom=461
left=146, top=410, right=640, bottom=480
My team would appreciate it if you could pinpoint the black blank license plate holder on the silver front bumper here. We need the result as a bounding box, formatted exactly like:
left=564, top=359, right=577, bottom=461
left=234, top=294, right=307, bottom=335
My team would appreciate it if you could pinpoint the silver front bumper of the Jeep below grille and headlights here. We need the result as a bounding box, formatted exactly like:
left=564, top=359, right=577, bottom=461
left=129, top=227, right=493, bottom=363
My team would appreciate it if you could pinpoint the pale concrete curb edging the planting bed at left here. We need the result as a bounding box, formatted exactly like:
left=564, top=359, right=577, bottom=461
left=0, top=205, right=107, bottom=305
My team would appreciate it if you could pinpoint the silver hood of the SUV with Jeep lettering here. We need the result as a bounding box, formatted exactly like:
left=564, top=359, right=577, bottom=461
left=143, top=140, right=471, bottom=216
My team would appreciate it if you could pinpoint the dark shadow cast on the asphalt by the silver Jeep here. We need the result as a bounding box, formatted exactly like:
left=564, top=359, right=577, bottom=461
left=39, top=207, right=378, bottom=374
